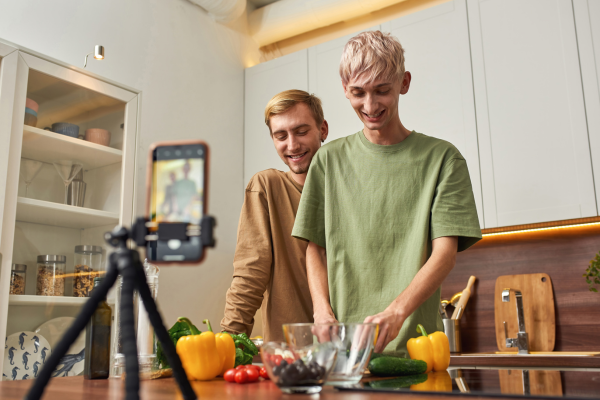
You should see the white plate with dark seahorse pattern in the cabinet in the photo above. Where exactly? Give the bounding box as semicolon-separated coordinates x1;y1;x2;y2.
2;331;52;381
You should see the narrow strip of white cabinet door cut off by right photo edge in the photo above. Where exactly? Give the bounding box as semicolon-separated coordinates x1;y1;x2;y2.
573;0;600;216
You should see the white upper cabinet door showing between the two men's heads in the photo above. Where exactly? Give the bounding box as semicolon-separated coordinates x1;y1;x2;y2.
308;25;380;143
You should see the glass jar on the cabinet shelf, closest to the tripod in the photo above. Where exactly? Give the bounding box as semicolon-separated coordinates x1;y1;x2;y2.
73;245;105;297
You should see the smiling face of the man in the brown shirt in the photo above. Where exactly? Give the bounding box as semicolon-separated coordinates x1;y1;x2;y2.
269;103;328;174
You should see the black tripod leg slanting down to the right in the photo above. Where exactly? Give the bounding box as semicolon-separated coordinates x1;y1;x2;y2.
136;263;198;400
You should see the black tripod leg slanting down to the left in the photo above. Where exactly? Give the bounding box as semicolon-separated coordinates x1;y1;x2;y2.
25;260;119;400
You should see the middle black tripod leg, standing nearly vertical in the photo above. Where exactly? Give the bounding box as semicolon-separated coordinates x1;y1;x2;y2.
119;250;140;400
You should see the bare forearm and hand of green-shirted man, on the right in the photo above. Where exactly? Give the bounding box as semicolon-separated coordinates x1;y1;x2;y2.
364;236;458;353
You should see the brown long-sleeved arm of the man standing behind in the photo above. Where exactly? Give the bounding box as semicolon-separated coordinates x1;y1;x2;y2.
221;189;273;336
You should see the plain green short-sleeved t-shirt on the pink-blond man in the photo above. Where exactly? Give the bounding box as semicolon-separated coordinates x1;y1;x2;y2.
292;131;481;356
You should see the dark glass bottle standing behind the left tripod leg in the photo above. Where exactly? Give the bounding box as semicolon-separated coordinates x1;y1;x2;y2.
83;277;112;379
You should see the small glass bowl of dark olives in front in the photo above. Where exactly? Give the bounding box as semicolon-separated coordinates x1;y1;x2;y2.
260;342;337;394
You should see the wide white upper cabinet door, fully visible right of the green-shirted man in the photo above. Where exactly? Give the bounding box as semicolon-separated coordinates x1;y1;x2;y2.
468;0;597;228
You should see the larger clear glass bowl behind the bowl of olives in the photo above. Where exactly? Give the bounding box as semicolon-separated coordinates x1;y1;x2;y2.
283;323;379;385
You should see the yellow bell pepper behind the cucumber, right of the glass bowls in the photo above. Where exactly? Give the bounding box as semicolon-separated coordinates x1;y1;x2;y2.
406;324;450;372
